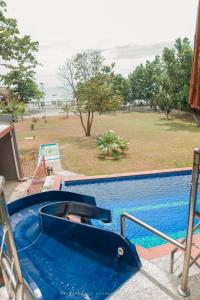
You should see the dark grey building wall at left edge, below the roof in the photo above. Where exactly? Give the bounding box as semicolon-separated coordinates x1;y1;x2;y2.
0;134;17;180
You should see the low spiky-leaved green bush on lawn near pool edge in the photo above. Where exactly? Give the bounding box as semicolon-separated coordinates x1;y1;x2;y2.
96;130;128;159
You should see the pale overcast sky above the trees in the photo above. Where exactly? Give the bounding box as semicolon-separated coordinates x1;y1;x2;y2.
6;0;198;99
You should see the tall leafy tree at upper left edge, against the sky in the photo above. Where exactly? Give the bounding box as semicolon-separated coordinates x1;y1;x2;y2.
0;1;43;102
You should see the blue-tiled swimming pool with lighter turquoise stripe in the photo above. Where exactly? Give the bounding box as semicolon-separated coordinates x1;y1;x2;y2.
61;171;200;248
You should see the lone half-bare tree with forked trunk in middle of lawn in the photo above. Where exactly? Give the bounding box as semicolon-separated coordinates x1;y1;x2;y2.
59;51;122;136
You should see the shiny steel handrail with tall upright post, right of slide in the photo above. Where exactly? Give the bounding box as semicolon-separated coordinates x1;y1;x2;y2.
121;148;200;297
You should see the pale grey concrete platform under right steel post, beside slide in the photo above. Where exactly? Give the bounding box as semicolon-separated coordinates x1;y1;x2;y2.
109;260;200;300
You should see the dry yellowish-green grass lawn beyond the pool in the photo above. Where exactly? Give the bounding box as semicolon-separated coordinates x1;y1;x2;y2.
16;112;200;175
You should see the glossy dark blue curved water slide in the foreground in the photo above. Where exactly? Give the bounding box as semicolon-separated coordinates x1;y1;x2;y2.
2;191;141;300
